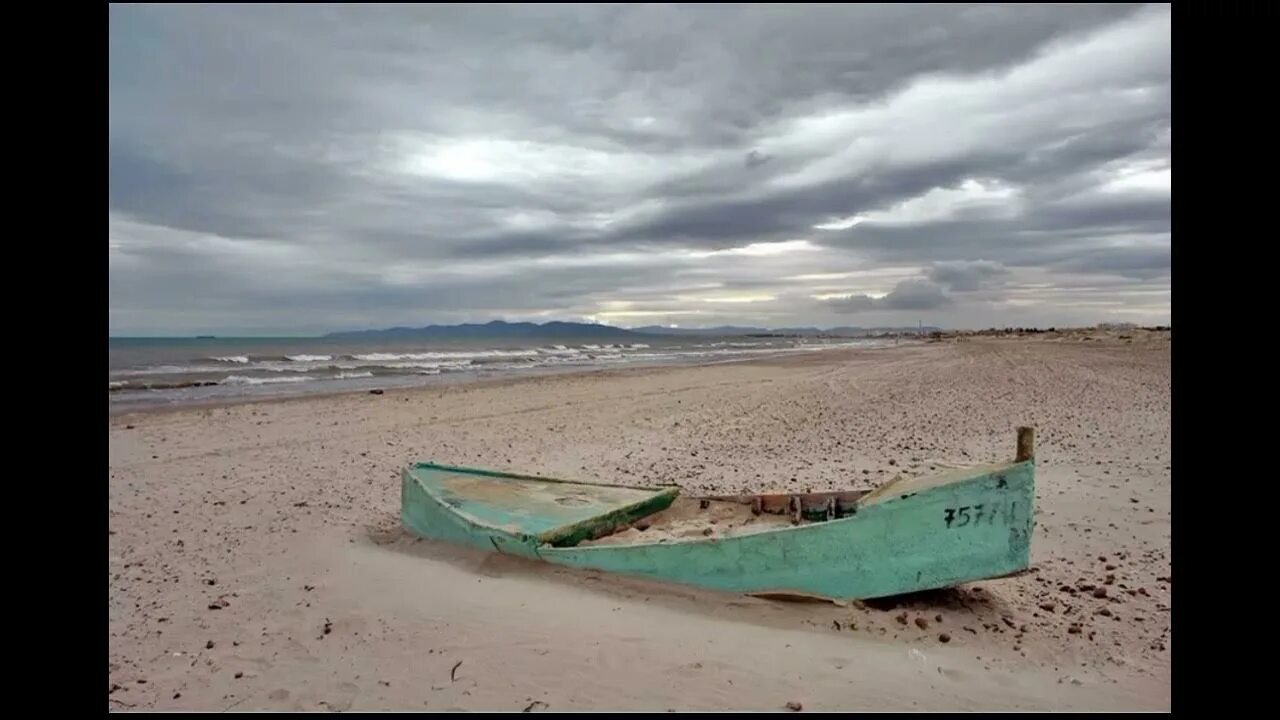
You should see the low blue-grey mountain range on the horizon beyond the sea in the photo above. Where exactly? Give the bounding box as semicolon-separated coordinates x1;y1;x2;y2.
325;320;938;340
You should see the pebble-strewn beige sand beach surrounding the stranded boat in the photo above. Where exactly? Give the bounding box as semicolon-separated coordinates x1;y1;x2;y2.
109;332;1172;711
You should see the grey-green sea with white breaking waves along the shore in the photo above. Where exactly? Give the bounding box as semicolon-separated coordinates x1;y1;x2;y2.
108;336;893;414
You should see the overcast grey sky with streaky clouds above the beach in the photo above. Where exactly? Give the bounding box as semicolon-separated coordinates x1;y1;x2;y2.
108;4;1172;334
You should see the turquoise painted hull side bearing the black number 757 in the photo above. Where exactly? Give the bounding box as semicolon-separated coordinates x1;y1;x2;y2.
538;462;1033;600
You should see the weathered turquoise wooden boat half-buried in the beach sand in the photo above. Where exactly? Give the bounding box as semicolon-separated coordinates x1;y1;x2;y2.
401;428;1036;600
